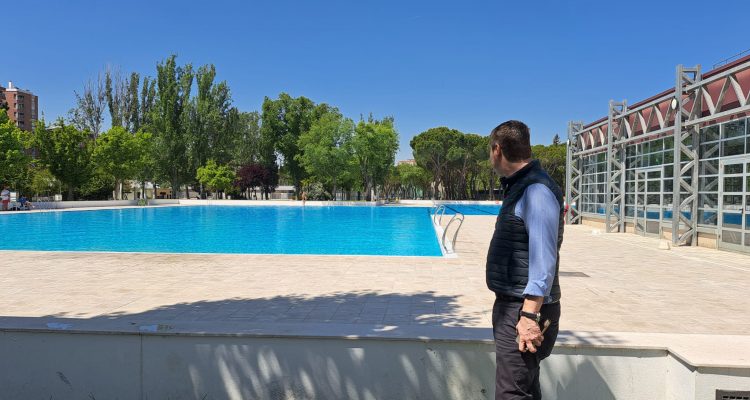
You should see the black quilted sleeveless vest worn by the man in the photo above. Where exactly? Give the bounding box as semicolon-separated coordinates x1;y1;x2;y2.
487;160;565;302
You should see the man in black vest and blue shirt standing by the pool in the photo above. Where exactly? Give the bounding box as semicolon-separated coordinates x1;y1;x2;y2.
487;121;564;400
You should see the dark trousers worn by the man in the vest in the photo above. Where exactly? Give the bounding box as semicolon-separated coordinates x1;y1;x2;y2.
492;296;560;400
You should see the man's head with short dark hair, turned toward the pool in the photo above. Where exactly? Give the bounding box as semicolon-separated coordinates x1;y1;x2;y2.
490;120;531;176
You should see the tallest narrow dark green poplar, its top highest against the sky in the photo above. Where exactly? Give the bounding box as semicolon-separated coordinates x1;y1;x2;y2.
150;55;193;197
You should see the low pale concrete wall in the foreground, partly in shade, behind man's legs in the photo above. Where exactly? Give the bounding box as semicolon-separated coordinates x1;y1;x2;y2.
0;331;750;400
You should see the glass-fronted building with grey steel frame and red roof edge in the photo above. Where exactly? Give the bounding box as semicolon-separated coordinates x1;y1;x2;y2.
566;56;750;252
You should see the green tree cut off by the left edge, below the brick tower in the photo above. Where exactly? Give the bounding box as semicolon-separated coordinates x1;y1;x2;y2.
0;109;31;189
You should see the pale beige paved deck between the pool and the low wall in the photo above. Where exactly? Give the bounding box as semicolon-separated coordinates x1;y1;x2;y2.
0;216;750;366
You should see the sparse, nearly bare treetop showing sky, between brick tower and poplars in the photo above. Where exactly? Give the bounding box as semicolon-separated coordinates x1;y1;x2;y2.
68;74;107;138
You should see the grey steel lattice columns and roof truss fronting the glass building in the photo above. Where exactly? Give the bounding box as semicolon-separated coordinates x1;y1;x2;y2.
565;57;750;245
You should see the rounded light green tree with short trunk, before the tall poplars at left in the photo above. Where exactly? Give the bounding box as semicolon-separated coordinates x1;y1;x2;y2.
92;126;141;200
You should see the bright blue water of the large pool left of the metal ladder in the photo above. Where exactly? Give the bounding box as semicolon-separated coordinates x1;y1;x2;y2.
0;206;442;256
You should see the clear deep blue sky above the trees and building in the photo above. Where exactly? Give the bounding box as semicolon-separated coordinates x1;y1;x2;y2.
0;0;750;159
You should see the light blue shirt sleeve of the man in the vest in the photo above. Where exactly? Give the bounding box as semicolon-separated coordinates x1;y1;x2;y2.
513;183;560;303
